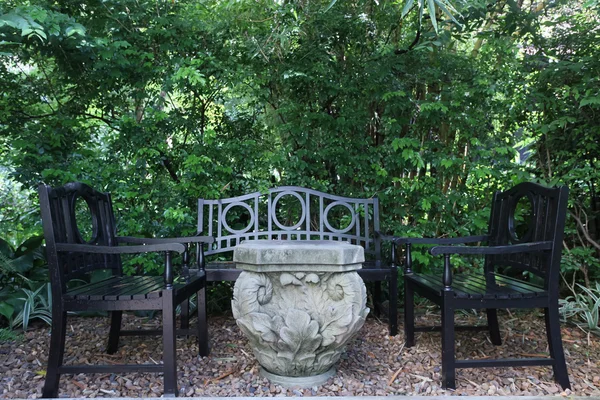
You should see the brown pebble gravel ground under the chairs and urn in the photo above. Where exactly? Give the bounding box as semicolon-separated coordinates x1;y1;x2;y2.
0;311;600;398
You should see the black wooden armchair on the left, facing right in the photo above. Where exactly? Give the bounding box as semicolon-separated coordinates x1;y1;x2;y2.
39;183;213;397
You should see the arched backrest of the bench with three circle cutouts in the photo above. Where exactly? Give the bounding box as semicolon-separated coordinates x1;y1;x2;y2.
198;186;381;261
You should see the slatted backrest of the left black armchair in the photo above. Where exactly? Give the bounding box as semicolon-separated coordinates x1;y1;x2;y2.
39;182;122;291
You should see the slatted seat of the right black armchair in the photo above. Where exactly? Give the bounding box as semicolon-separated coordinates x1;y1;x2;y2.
405;273;548;300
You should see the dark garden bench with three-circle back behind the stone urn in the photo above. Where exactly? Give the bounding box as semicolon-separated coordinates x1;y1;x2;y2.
191;186;398;352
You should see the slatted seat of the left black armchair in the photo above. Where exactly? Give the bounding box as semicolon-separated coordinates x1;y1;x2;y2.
64;276;200;301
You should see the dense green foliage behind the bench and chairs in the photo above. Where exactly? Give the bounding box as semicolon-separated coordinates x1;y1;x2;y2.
0;0;600;314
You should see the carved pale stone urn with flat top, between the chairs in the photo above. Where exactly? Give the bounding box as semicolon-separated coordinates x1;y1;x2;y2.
232;240;369;387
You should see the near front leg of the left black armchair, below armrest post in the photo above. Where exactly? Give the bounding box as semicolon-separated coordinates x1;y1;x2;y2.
162;290;179;397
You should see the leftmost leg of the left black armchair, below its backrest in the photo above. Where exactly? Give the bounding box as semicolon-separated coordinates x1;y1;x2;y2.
42;311;67;398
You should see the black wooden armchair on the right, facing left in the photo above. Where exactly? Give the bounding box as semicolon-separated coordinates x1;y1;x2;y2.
395;183;570;389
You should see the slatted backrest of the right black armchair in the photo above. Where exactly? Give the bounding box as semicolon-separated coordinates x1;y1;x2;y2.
485;182;569;288
